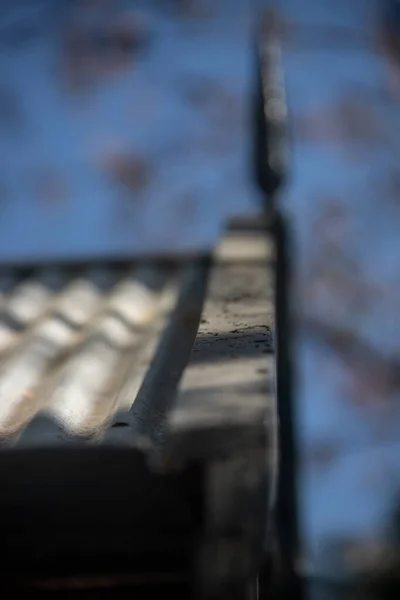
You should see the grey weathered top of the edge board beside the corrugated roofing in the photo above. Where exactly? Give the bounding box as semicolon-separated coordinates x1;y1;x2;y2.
168;233;275;455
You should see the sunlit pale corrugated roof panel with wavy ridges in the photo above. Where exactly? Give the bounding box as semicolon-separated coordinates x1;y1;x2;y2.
0;267;177;442
